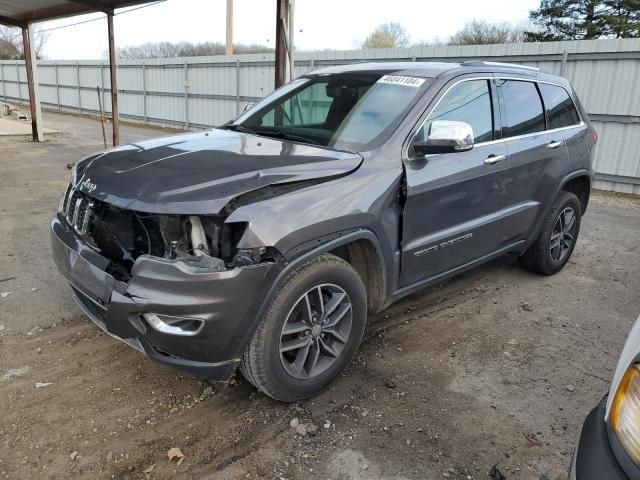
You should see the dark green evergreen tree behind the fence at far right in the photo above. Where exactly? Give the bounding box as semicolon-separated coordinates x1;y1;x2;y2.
525;0;640;41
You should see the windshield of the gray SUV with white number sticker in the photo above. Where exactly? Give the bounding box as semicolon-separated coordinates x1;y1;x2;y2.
226;72;428;150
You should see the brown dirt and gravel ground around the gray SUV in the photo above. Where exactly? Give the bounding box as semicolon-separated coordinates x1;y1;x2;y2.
0;114;640;480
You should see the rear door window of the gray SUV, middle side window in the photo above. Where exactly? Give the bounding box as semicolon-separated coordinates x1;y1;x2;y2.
498;80;544;138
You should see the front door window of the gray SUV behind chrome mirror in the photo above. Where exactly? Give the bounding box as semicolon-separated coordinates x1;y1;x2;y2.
418;80;493;143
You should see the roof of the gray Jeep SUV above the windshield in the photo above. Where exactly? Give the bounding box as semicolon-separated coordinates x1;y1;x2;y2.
309;61;552;78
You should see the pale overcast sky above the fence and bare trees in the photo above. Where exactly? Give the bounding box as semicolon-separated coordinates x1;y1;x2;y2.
39;0;540;60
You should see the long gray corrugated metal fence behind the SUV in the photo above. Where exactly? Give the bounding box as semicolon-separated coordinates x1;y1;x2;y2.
0;39;640;194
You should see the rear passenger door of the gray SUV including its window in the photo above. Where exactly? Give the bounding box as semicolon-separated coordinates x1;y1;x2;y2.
496;78;569;241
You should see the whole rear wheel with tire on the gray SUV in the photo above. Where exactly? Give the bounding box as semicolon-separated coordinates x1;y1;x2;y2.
520;191;582;275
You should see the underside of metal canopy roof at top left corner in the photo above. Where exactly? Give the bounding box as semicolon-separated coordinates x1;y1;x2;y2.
0;0;151;27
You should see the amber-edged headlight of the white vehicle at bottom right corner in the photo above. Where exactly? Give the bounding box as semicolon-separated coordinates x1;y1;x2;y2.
610;365;640;465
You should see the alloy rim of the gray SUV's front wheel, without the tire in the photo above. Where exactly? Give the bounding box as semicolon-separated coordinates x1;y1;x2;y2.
279;283;353;379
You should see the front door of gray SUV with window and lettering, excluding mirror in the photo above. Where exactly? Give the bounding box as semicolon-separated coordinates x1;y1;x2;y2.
400;79;508;287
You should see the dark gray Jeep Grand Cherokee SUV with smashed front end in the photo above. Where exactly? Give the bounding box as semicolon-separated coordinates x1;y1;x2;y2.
51;61;597;401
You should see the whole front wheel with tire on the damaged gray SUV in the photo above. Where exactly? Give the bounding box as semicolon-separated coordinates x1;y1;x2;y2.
240;254;367;402
